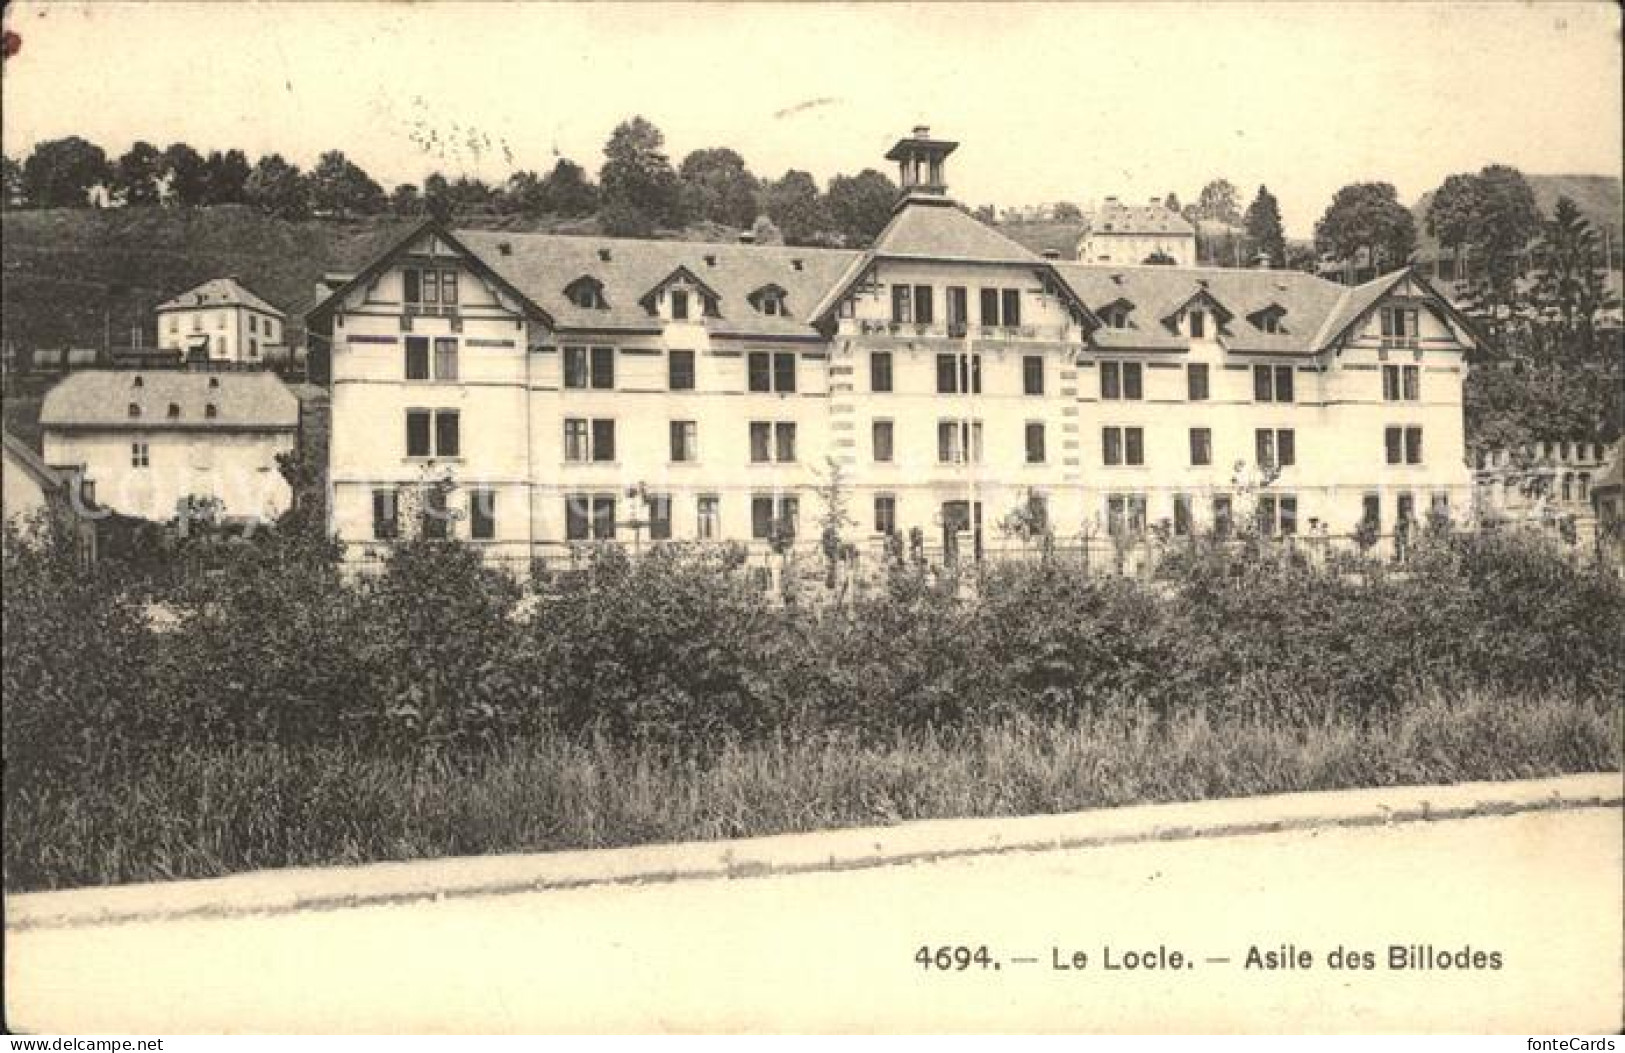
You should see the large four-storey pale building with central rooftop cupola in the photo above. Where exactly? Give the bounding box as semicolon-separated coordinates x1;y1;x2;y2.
307;130;1472;559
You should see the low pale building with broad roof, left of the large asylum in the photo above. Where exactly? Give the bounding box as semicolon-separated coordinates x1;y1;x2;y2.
39;369;299;522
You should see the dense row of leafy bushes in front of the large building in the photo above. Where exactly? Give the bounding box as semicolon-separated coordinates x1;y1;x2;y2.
3;523;1625;783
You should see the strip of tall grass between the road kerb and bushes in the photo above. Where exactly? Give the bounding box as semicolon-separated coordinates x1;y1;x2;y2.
5;692;1622;891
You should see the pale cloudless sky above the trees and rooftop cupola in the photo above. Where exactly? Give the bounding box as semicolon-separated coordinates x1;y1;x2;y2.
0;0;1625;237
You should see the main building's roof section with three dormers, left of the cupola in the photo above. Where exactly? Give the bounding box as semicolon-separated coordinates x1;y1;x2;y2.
455;231;863;338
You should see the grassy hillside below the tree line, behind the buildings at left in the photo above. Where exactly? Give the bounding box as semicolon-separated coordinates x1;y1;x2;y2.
0;205;738;348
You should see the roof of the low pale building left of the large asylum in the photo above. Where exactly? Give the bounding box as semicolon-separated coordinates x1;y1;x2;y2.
39;369;299;431
